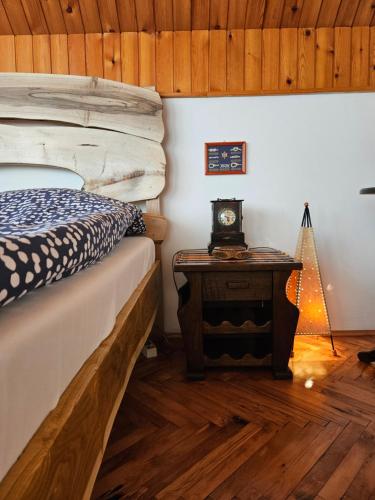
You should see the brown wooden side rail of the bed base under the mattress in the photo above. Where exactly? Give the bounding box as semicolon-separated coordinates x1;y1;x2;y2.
0;261;161;500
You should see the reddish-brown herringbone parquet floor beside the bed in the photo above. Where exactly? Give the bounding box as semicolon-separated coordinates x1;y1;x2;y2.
93;337;375;500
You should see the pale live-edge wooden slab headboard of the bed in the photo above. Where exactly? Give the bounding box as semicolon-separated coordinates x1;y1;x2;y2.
0;73;165;202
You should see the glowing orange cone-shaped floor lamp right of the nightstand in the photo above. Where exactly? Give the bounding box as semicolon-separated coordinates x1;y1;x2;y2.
287;203;337;355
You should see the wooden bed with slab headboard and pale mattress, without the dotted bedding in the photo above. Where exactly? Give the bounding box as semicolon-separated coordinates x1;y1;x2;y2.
0;75;166;499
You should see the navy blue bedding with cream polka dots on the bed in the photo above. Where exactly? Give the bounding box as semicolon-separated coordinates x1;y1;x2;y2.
0;189;146;307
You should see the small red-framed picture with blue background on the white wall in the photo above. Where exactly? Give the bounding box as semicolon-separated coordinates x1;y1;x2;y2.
205;141;246;175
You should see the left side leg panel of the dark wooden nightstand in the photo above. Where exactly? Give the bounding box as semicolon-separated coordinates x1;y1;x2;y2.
177;273;205;380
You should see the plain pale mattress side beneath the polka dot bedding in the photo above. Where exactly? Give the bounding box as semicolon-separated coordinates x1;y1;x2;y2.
0;236;155;480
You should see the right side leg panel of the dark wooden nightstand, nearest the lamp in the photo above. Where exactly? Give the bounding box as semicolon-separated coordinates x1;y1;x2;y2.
272;271;299;380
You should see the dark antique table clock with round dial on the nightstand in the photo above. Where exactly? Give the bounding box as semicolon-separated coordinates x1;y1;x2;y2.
208;198;247;255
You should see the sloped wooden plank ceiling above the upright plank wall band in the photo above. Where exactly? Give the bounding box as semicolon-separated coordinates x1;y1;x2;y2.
0;0;375;35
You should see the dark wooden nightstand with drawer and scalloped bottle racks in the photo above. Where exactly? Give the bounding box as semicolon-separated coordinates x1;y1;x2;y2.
174;248;302;380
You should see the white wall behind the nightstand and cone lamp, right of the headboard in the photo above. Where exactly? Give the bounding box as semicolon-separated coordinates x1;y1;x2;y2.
162;93;375;332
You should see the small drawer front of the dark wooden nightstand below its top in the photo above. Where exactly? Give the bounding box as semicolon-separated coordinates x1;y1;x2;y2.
202;271;272;301
